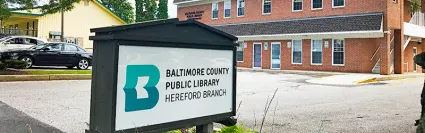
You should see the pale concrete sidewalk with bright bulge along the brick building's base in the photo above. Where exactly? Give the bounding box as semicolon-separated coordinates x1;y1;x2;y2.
238;68;425;85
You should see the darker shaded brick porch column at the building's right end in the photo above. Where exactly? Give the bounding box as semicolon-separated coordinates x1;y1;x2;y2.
394;29;405;74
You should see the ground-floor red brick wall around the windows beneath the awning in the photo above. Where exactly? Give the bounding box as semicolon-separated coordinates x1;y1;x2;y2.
238;39;379;73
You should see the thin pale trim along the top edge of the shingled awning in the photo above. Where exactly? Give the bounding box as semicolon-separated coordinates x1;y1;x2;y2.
211;12;384;27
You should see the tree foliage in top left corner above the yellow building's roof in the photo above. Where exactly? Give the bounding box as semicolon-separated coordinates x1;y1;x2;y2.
0;0;81;20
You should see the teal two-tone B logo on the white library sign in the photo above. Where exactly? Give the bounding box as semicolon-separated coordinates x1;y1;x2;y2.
124;65;159;112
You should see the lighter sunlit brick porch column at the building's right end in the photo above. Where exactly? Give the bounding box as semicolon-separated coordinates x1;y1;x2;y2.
380;34;391;75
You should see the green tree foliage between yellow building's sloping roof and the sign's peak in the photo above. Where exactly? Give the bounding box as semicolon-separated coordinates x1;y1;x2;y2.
101;0;133;23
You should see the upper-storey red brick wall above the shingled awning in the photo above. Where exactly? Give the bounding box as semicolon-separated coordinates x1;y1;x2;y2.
177;0;386;24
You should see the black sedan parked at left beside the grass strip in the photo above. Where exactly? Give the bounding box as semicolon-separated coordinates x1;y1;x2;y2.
0;43;93;69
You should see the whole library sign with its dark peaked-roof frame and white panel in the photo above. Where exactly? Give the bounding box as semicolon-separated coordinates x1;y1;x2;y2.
87;19;238;133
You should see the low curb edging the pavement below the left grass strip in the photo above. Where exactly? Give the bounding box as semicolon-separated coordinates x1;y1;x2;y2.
0;74;91;82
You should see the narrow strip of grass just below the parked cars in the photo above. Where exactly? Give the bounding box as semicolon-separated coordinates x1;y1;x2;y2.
0;70;92;75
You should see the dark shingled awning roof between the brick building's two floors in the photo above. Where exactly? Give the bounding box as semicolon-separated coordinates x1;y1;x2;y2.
212;13;383;36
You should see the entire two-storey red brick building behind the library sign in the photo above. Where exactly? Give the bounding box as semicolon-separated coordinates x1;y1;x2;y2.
174;0;425;75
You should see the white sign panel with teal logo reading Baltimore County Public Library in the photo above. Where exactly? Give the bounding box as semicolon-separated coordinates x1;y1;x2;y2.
115;46;233;130
